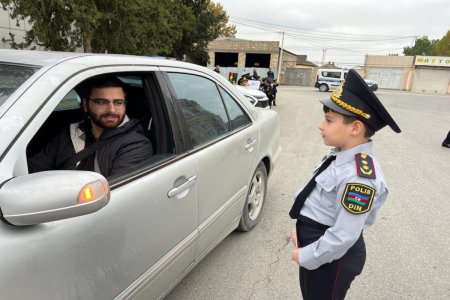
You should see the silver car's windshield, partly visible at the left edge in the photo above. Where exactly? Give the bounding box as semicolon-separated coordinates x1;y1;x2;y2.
0;63;37;106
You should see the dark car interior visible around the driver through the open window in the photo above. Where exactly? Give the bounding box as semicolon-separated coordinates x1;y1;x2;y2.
27;73;174;180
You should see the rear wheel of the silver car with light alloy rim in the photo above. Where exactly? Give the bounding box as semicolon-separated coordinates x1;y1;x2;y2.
238;162;267;231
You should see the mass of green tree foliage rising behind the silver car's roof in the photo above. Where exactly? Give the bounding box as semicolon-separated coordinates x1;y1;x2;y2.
0;0;236;64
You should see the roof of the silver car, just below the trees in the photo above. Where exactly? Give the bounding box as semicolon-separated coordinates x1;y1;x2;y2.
0;49;207;73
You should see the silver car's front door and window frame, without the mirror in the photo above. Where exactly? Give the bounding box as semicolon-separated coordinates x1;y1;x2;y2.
0;63;198;299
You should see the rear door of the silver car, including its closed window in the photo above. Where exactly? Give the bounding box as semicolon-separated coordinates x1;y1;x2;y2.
163;70;259;256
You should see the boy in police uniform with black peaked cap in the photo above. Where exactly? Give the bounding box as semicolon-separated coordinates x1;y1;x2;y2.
289;70;400;300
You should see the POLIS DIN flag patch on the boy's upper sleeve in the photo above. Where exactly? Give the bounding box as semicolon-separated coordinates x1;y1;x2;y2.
341;183;375;214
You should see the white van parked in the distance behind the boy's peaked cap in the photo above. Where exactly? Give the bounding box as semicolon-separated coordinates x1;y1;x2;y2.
314;69;378;92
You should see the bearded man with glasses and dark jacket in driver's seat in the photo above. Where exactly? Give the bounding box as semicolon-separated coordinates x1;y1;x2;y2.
28;77;153;177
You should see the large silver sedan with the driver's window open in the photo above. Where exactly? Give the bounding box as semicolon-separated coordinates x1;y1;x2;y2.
0;50;280;300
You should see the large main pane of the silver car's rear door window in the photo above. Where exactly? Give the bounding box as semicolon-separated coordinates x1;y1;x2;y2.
168;73;231;147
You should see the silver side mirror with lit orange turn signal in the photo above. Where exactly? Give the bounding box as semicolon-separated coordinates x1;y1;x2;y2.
0;171;110;225
